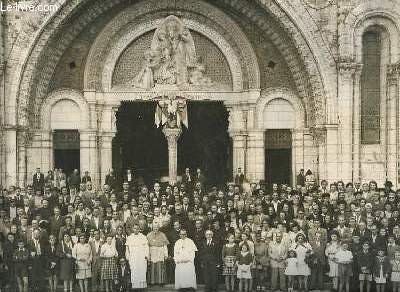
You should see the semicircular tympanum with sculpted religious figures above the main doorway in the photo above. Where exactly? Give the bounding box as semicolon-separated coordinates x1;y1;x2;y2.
113;15;232;90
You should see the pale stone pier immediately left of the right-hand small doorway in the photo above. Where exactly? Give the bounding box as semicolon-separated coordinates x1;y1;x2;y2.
246;130;265;181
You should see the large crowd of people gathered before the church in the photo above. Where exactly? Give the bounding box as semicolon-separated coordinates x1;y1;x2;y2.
0;168;400;292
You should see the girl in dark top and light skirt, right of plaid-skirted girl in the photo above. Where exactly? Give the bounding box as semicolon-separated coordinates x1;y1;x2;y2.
237;243;254;292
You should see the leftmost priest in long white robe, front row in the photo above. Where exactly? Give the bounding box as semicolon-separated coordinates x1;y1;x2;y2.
125;225;149;289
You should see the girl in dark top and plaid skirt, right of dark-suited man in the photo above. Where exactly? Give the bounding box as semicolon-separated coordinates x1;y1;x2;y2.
222;234;239;292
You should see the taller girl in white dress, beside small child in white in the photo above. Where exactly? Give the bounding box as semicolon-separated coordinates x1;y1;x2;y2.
289;233;313;291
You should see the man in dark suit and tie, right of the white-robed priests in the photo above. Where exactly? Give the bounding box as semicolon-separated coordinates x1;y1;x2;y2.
200;230;220;292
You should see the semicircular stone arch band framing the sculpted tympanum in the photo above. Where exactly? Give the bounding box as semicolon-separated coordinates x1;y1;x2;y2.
84;0;260;91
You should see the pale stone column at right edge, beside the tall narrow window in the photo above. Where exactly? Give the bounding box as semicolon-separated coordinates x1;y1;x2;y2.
386;64;400;189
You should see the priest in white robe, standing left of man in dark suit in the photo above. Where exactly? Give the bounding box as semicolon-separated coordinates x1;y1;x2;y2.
174;229;197;289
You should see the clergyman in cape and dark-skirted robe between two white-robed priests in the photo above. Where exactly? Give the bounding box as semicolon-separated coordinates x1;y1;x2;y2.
147;223;169;286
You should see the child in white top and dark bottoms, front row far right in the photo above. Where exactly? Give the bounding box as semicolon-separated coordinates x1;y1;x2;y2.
335;241;353;292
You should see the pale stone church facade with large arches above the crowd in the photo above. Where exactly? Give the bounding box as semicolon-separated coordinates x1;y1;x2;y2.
0;0;400;186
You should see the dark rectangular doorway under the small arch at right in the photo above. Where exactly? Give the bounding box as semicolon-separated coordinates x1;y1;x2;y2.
265;129;292;185
